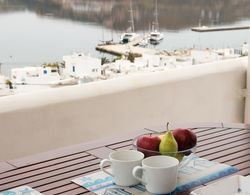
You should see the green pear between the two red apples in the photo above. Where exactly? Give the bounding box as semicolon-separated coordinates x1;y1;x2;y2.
159;130;178;157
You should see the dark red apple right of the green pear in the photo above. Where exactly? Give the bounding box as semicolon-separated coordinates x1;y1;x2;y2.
173;128;197;151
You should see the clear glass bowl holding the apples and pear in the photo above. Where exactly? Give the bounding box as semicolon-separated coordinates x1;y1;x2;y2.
132;133;196;163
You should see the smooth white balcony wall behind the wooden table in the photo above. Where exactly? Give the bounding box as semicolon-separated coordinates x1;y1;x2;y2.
0;58;247;161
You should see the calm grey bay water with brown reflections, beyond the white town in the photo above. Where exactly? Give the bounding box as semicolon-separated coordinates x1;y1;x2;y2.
0;0;250;75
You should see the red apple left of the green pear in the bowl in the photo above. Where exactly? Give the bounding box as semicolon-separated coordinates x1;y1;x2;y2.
136;134;161;157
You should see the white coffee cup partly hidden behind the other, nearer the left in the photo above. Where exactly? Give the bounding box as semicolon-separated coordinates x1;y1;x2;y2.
100;150;144;186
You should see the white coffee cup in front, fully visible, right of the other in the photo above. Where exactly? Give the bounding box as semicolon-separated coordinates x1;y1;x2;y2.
133;155;179;194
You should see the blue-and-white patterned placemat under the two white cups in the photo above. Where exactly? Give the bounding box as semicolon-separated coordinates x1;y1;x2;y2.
72;155;237;195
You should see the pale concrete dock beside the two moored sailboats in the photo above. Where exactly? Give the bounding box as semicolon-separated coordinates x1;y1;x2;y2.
96;36;159;56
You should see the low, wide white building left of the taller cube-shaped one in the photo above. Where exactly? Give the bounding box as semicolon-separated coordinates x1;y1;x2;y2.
11;67;60;85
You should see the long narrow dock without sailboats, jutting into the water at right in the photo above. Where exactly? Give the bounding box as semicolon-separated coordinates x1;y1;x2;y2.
191;26;250;32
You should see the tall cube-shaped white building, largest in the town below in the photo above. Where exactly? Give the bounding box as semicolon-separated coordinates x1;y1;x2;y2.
63;53;101;79
